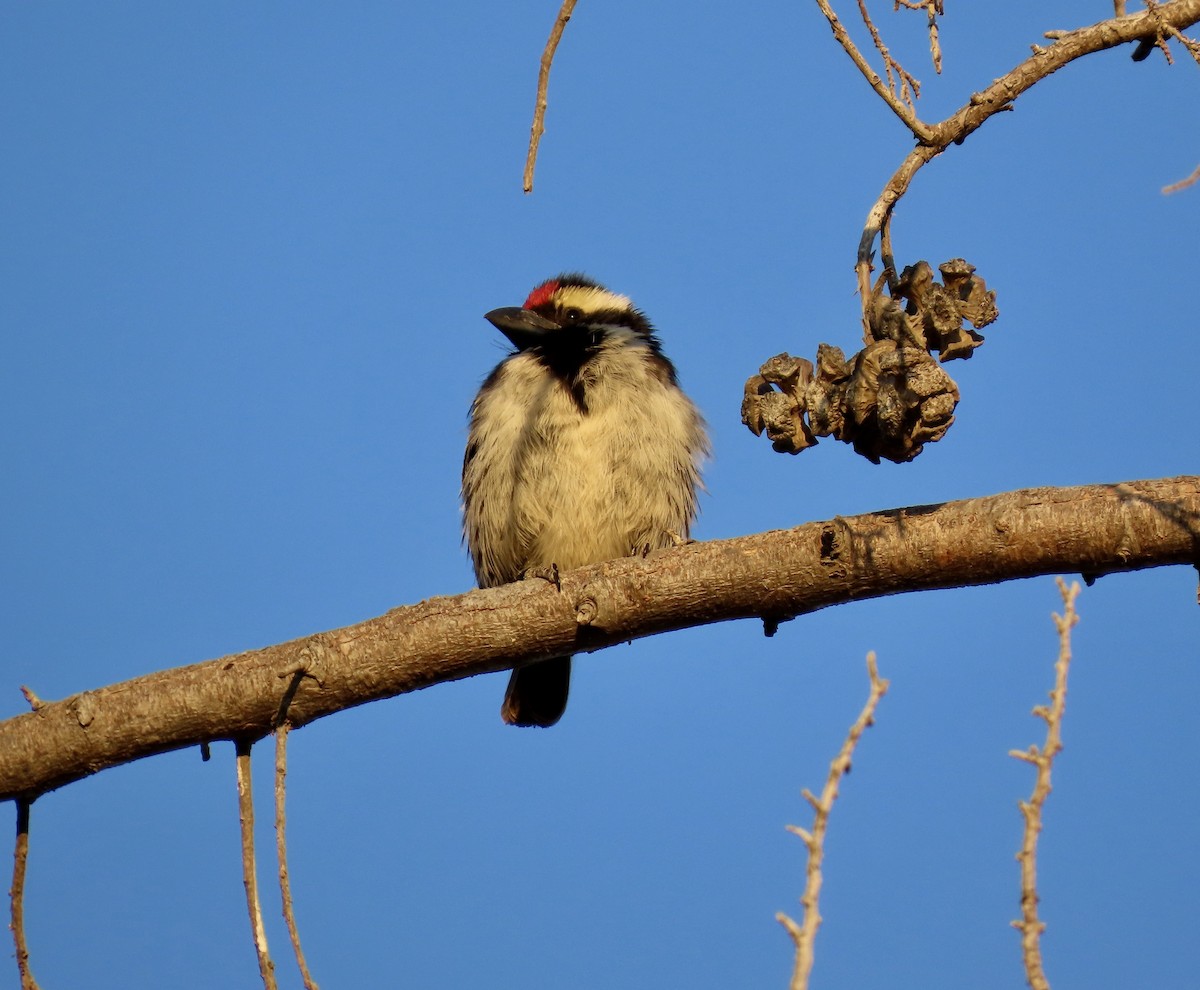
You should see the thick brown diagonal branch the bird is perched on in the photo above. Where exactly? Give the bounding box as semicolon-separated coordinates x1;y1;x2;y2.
0;476;1200;799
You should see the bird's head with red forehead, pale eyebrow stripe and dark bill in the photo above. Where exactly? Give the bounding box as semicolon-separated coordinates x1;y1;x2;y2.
484;272;659;358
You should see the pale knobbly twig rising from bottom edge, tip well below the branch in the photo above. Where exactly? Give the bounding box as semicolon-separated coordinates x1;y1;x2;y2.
775;652;888;990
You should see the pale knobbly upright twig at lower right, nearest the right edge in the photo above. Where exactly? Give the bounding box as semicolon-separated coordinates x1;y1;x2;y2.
1009;577;1079;990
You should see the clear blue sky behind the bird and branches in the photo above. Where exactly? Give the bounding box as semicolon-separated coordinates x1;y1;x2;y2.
0;0;1200;990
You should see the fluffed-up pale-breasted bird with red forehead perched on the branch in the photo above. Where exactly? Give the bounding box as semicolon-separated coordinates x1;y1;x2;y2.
462;272;709;726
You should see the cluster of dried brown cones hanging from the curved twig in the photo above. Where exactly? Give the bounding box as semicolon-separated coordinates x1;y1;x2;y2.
742;258;998;464
